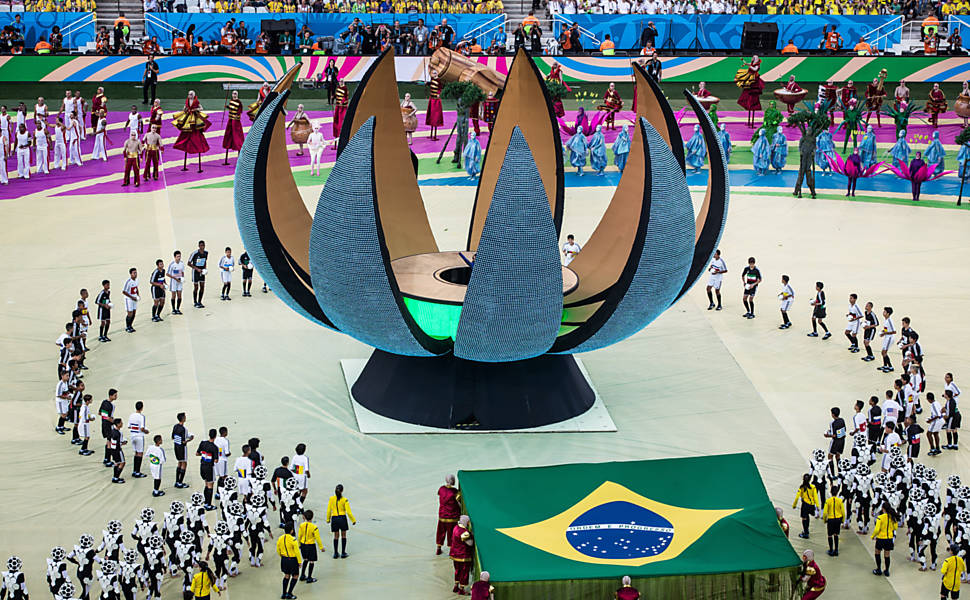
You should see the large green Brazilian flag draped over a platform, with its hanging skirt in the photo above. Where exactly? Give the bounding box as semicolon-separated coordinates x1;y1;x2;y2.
459;454;800;600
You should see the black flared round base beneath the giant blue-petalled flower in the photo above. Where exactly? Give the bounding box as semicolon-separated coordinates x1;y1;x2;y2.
351;350;596;430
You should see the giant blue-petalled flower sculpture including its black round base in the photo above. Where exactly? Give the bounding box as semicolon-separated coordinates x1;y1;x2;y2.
235;50;728;429
